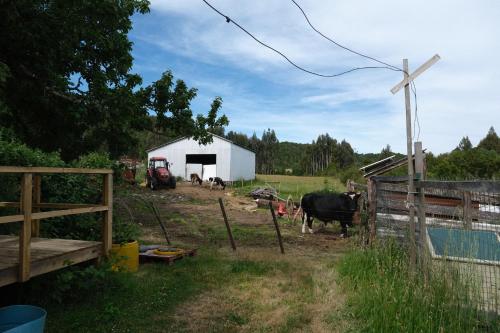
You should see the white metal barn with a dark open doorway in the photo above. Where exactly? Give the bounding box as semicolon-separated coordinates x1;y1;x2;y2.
147;134;255;181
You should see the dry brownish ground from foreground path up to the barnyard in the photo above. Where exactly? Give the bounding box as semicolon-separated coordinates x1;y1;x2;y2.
115;182;350;332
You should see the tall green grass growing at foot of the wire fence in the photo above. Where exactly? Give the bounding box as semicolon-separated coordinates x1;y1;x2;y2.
338;242;499;332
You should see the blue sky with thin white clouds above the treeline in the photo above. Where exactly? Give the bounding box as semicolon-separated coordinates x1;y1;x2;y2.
129;0;500;153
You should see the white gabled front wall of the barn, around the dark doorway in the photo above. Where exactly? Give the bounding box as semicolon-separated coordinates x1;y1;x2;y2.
148;136;231;180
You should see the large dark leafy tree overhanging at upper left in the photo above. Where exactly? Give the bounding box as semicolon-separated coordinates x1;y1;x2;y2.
0;0;227;160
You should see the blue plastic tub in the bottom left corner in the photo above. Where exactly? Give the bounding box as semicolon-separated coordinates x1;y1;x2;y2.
0;305;47;333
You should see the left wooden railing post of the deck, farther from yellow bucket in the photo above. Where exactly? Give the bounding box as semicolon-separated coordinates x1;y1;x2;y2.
19;173;33;282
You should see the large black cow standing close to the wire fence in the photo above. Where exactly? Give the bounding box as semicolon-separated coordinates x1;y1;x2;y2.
300;192;361;237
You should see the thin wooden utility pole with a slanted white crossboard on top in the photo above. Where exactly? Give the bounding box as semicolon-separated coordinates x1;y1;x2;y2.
391;54;440;269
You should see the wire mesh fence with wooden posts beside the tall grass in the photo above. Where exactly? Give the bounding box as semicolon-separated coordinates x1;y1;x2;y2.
370;177;500;318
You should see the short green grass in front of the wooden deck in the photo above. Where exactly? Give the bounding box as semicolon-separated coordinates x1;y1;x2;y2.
4;248;310;332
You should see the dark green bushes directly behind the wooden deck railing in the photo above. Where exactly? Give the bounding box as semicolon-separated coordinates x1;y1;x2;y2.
0;140;137;240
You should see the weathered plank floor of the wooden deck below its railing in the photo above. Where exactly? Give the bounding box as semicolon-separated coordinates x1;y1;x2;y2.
0;235;103;287
